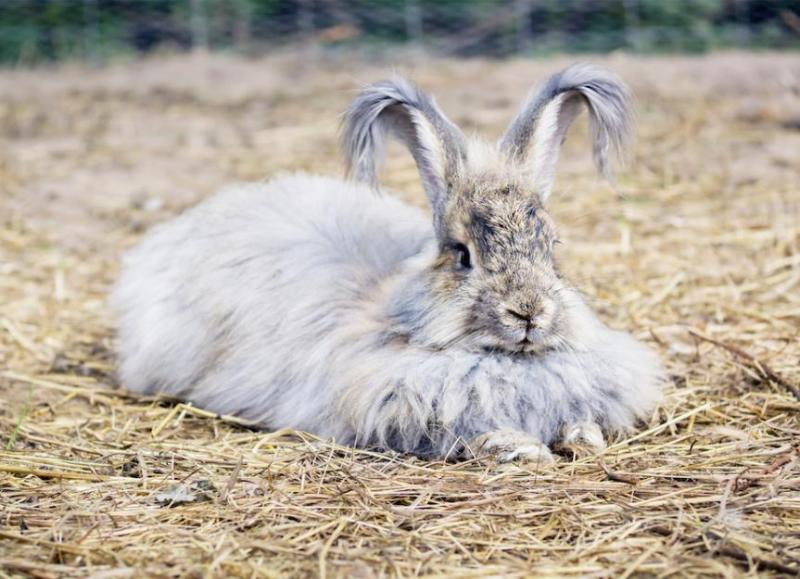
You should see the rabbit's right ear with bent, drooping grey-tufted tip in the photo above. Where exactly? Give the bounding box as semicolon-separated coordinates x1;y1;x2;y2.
500;64;632;201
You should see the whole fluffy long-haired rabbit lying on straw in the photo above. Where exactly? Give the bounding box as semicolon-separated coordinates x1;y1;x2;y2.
112;64;663;462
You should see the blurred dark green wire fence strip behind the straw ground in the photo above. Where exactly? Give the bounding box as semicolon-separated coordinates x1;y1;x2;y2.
0;0;800;65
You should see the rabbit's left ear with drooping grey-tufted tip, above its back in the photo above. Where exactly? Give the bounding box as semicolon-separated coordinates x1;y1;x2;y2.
342;76;465;232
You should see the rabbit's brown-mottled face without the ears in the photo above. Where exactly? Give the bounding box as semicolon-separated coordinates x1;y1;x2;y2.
436;186;567;353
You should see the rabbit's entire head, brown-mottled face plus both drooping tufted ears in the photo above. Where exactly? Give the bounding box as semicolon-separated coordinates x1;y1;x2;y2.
343;65;631;352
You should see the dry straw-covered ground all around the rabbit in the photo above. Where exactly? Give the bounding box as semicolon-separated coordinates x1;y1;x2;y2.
0;54;800;577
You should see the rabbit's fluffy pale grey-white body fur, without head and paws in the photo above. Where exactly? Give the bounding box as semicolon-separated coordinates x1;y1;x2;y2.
113;175;659;456
